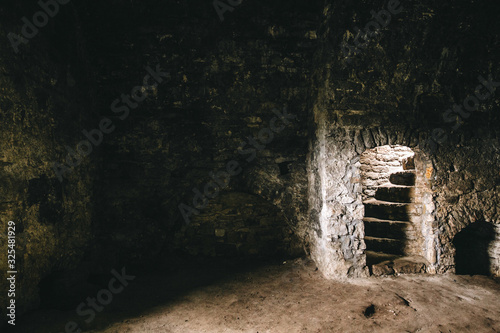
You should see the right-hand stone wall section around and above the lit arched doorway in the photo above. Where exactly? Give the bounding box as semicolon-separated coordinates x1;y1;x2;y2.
309;1;500;277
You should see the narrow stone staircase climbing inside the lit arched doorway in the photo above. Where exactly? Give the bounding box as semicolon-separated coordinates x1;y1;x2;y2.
363;160;425;275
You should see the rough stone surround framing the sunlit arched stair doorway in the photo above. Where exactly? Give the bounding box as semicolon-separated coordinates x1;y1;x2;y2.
308;125;440;279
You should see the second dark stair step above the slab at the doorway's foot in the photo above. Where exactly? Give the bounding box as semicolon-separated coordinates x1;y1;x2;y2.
363;217;416;239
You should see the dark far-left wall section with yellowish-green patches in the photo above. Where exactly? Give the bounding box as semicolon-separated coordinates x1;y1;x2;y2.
0;2;97;325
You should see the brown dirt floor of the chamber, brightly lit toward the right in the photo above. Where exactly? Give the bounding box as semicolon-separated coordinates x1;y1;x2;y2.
5;259;500;333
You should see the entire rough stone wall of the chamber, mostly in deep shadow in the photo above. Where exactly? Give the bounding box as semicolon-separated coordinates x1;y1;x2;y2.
0;0;500;322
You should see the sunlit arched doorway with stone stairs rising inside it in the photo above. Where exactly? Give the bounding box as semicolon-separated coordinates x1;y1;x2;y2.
360;145;435;275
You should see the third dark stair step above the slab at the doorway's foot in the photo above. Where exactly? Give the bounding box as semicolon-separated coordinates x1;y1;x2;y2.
363;199;416;222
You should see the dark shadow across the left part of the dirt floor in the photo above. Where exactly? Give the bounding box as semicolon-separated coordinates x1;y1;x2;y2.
2;258;292;333
